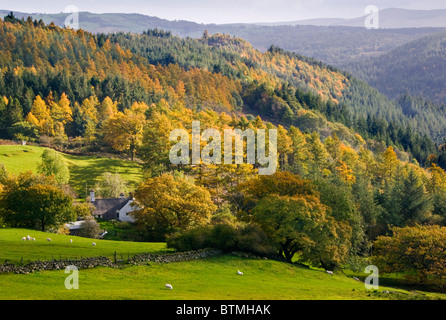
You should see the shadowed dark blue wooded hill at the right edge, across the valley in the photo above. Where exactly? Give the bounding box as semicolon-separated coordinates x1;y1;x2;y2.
344;32;446;105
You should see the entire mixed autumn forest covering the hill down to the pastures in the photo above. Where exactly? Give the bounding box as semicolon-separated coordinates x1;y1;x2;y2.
0;15;446;289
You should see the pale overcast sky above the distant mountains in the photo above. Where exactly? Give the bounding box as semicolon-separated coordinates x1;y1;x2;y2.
0;0;446;23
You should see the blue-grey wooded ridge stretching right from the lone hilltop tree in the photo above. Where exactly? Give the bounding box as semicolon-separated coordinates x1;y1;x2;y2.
208;25;446;67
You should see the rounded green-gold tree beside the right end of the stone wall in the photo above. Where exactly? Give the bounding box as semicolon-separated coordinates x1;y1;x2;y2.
253;191;351;269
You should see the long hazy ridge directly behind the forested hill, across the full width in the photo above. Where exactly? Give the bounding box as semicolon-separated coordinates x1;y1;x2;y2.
0;9;446;67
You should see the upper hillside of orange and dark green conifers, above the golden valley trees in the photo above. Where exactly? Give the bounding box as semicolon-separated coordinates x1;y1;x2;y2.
0;14;439;164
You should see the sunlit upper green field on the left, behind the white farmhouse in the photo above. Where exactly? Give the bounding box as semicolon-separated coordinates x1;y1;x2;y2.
0;145;142;198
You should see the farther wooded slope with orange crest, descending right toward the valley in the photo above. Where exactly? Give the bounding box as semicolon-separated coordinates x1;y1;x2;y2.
104;32;445;163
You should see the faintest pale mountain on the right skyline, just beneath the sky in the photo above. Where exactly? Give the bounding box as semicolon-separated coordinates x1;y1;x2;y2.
260;8;446;29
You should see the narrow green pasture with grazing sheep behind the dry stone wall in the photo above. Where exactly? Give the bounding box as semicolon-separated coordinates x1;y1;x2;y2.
0;228;171;264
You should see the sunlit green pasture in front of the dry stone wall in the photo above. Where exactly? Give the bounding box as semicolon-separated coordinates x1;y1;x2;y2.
0;256;412;300
